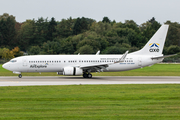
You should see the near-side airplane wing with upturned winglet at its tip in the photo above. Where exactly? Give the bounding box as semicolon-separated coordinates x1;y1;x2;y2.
79;51;129;72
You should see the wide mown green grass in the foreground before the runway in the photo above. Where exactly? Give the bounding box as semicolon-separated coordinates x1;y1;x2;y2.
0;84;180;120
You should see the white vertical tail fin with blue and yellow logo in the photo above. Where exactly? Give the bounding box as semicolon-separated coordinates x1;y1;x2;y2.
131;25;169;56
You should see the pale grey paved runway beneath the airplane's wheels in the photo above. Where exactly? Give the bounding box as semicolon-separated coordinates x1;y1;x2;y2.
0;76;180;86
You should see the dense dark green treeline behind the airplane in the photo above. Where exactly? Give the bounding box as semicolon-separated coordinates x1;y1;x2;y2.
0;13;180;57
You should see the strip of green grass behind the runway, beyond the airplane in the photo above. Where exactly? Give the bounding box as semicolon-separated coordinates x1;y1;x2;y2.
0;64;180;76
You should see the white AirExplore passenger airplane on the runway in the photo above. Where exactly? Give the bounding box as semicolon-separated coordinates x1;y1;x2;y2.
2;25;172;78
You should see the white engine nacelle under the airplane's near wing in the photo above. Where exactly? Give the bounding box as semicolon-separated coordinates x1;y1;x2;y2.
63;67;83;75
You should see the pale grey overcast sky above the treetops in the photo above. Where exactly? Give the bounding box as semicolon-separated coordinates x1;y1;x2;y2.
0;0;180;25
